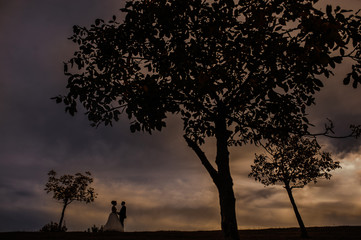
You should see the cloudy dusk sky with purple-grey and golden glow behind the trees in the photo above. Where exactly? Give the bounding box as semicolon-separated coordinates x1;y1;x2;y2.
0;0;361;231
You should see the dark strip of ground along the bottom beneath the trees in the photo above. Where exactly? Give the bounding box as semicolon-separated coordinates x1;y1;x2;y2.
0;226;361;240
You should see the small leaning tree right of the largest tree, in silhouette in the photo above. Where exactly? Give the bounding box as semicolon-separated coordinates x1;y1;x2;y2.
249;136;340;238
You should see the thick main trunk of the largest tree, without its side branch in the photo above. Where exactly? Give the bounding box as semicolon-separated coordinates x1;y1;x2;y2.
213;113;239;240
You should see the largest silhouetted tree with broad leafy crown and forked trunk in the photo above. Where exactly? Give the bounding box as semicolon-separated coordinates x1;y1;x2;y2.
55;0;361;239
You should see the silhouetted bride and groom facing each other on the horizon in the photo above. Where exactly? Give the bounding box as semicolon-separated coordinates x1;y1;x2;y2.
104;201;127;232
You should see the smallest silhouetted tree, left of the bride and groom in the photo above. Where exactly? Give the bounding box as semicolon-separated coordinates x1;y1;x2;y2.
44;170;97;230
